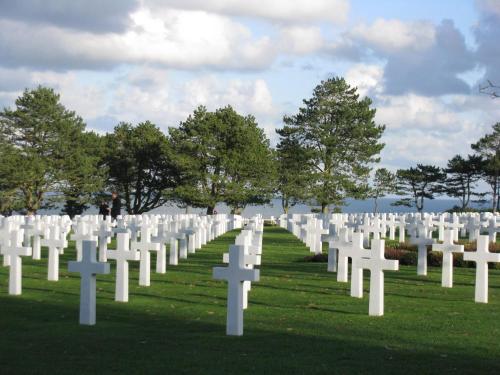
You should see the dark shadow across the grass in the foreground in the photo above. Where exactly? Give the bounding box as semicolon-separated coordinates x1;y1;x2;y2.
0;296;500;375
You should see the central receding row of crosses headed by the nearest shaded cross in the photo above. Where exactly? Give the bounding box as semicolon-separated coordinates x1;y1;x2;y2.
213;216;264;336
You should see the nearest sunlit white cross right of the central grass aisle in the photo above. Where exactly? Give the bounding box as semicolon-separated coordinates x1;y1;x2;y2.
359;240;399;316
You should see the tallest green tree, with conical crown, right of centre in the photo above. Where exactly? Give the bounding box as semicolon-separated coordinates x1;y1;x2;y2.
277;78;385;213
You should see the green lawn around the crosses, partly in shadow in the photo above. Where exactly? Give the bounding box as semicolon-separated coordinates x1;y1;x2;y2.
0;227;500;375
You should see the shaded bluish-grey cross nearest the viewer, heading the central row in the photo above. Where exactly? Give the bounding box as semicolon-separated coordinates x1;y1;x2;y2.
213;245;260;336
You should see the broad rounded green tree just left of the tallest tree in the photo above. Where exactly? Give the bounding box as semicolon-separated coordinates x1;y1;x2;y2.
170;106;275;214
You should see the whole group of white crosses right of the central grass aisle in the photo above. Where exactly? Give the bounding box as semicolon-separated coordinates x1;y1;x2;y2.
280;214;500;315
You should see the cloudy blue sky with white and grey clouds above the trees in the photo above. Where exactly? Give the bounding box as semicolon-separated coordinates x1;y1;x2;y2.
0;0;500;169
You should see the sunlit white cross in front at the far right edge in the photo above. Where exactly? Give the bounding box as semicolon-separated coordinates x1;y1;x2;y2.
464;235;500;303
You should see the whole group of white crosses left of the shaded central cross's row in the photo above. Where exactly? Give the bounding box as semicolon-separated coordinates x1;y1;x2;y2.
0;215;241;324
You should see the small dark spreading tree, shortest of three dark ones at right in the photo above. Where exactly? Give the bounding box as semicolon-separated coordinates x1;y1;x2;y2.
393;164;445;212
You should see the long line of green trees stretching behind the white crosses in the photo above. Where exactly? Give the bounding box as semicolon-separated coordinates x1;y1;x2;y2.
0;82;500;216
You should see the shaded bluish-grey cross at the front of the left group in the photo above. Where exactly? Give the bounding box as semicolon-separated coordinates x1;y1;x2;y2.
68;240;109;325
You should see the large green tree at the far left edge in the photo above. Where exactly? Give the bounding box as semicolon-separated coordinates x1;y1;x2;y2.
0;86;85;214
